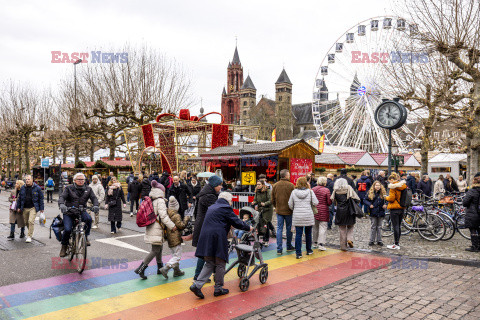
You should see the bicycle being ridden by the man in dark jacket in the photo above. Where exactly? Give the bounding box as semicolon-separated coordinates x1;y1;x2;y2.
67;206;87;274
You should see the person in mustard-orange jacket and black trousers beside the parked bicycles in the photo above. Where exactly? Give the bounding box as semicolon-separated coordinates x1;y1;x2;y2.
385;172;407;250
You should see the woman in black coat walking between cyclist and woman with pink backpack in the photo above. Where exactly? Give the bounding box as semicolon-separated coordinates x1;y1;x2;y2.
105;177;127;234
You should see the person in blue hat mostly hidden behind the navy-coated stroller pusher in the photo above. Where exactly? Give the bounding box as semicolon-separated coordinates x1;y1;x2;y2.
192;175;222;280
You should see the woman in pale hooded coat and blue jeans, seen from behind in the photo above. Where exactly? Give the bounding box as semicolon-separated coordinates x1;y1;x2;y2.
288;177;318;259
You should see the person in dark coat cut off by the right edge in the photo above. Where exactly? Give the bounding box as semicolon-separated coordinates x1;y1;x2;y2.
463;172;480;252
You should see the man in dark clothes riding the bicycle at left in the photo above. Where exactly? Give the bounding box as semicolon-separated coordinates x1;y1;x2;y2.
58;173;99;257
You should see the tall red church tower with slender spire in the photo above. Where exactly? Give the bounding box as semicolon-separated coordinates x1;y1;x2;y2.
222;47;243;124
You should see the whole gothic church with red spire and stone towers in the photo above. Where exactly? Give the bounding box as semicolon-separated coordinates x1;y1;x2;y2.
221;47;318;141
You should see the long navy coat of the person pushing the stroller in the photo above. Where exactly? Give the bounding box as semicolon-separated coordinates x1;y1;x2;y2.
195;199;250;262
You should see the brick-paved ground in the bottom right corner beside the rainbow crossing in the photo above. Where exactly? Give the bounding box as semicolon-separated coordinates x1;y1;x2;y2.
239;262;480;320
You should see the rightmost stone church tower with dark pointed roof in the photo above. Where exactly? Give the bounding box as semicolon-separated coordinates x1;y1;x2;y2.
275;69;293;141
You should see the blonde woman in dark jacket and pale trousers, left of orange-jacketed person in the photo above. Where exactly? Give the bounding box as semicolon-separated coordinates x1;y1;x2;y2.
364;181;387;246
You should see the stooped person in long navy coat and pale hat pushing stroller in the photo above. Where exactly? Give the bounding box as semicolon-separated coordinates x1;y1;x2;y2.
190;192;253;299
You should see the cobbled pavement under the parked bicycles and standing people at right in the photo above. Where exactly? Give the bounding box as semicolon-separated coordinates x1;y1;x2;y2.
327;218;480;261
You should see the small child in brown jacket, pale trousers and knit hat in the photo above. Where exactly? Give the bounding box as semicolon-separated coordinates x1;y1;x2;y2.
160;196;190;279
